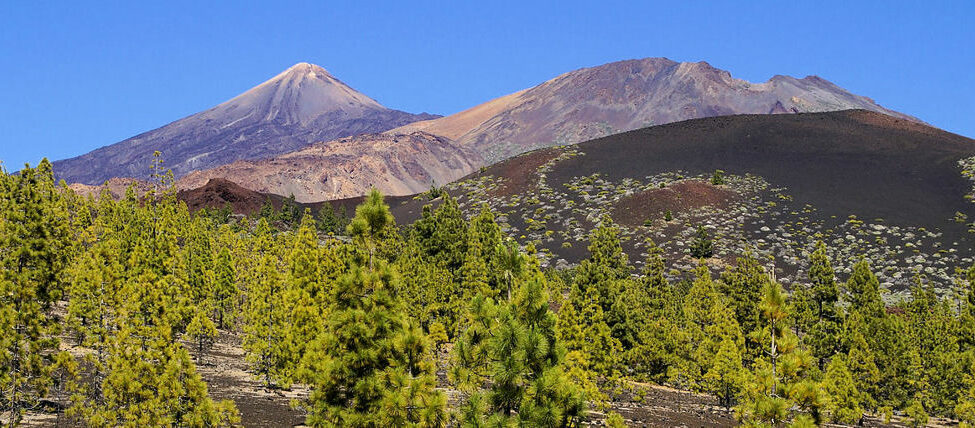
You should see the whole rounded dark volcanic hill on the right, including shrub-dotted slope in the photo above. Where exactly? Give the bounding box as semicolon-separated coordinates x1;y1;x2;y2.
394;110;975;290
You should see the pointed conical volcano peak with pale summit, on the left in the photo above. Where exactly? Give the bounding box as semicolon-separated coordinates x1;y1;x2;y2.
54;63;437;184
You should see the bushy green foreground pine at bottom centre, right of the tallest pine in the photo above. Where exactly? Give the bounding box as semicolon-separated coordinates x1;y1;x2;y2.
450;274;585;427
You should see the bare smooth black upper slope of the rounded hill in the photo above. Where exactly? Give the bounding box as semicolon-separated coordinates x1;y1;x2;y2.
556;110;975;232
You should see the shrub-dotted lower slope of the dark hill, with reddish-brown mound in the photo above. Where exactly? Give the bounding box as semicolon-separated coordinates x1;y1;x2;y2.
424;144;973;301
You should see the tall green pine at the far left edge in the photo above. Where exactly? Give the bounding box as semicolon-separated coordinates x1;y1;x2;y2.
0;159;67;425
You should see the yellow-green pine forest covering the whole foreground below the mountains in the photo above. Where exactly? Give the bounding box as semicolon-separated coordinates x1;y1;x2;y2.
0;161;975;427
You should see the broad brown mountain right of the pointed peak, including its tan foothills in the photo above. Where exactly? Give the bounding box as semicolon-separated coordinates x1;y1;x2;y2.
187;58;917;201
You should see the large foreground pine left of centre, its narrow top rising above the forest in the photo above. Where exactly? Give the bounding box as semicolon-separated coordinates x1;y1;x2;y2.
302;189;446;426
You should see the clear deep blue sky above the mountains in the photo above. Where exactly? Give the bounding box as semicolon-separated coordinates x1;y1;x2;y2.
0;0;975;169
